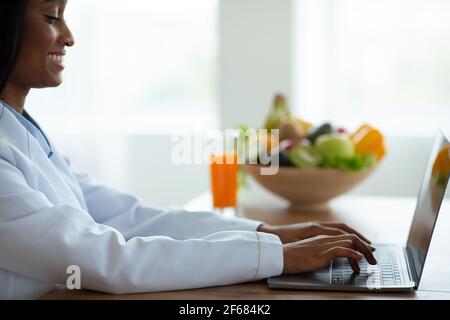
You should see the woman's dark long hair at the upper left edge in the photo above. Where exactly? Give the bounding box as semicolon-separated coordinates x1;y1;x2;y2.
0;0;28;96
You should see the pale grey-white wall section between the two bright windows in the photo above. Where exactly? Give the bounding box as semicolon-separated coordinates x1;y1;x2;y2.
218;0;293;128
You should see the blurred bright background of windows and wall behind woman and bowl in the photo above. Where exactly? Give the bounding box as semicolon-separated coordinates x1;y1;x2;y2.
27;0;450;206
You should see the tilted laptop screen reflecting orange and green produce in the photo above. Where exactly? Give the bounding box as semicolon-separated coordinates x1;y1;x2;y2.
408;131;450;280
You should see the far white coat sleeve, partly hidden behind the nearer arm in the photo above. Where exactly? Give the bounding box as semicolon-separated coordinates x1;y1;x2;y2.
64;157;268;240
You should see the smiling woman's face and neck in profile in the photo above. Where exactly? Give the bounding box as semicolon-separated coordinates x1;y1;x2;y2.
0;0;74;113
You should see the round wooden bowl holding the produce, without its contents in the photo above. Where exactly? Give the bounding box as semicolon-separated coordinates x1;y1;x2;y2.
243;165;377;211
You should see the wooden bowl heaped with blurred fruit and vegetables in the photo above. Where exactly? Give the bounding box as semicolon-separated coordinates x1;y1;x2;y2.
241;95;386;211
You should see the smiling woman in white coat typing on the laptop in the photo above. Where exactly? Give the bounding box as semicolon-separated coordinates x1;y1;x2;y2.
0;0;376;299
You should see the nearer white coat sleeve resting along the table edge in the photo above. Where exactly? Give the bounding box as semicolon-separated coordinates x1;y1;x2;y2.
0;156;283;294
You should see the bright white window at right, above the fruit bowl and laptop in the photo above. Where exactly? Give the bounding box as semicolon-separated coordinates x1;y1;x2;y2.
295;0;450;135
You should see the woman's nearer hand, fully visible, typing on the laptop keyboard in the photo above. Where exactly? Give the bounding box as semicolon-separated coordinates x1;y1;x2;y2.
283;234;377;274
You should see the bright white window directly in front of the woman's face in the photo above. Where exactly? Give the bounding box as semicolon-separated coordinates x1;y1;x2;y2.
28;0;218;133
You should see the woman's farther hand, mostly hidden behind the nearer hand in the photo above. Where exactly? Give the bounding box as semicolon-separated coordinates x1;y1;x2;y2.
258;222;371;244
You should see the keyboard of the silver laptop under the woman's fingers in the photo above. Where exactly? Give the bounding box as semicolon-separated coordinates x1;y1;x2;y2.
331;246;404;287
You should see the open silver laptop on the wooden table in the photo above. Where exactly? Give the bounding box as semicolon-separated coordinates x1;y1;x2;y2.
267;130;450;291
